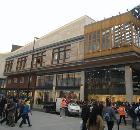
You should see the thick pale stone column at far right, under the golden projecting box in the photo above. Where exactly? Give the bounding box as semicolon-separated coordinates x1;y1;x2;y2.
125;66;133;104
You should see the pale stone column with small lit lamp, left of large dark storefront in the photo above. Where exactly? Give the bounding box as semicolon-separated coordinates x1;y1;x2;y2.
80;71;85;101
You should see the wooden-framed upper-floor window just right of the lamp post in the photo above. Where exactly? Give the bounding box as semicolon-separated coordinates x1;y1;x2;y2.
32;51;46;68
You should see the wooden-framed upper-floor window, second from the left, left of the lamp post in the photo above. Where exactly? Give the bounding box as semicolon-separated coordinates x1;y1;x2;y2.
17;56;28;70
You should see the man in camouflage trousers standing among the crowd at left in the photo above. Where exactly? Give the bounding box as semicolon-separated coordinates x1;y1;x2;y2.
7;97;16;127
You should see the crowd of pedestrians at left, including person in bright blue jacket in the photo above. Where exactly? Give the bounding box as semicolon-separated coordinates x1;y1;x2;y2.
0;96;33;127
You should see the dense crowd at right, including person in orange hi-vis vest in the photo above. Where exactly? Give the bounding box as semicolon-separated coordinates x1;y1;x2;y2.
79;101;140;130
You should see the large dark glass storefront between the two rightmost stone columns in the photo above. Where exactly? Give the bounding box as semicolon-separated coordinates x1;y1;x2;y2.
85;67;126;101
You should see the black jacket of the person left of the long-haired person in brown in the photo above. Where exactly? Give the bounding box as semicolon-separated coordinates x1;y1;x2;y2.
81;105;90;120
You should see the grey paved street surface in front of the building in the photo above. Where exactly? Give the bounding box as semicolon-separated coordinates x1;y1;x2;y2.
0;108;140;130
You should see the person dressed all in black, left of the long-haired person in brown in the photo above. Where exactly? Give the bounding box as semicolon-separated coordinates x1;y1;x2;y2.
81;102;90;130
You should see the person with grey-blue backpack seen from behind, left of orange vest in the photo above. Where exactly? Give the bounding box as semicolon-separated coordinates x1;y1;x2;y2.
105;102;117;130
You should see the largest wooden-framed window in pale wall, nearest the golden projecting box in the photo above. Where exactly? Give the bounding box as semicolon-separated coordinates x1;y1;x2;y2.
52;45;71;64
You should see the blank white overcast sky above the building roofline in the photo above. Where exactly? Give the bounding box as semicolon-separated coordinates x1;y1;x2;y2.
0;0;140;53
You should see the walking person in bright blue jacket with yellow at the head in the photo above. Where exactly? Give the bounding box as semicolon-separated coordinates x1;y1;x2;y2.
19;101;32;128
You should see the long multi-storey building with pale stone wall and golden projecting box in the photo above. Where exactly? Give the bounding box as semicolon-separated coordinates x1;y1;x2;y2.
4;6;140;102
